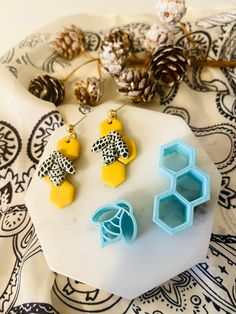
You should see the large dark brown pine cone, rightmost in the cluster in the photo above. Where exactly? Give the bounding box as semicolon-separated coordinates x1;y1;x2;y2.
151;45;188;86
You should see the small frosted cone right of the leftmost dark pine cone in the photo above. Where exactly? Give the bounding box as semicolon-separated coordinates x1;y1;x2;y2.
74;76;104;106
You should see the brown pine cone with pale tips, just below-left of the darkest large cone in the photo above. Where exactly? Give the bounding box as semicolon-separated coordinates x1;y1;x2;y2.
116;68;157;103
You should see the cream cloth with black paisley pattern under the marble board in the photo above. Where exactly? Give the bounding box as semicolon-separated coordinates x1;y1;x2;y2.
0;11;236;314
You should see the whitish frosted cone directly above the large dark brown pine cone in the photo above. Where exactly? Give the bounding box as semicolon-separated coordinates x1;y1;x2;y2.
144;24;173;55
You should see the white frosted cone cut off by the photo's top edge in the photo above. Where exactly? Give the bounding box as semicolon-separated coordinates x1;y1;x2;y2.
156;0;187;25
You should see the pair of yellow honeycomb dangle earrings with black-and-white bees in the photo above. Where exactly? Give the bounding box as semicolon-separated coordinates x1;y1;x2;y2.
38;105;137;208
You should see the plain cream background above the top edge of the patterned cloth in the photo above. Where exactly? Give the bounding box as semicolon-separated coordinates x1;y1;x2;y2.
0;0;236;55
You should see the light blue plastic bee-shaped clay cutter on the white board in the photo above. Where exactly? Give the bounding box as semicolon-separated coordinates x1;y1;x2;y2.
91;200;137;247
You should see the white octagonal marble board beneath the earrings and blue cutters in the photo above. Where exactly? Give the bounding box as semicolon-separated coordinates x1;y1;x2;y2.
24;102;221;299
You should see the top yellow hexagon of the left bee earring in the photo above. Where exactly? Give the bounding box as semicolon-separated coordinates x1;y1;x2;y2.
57;136;80;160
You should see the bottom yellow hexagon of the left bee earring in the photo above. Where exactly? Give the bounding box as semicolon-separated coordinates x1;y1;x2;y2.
50;181;75;208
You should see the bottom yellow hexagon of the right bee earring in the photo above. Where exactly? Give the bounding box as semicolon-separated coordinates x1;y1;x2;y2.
102;161;125;188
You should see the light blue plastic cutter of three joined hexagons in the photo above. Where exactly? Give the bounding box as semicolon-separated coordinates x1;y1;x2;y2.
153;140;210;234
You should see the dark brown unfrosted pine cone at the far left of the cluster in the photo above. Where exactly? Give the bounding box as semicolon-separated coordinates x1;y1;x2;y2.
28;74;65;106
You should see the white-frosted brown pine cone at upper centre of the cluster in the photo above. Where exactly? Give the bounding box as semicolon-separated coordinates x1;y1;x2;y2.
99;29;133;76
